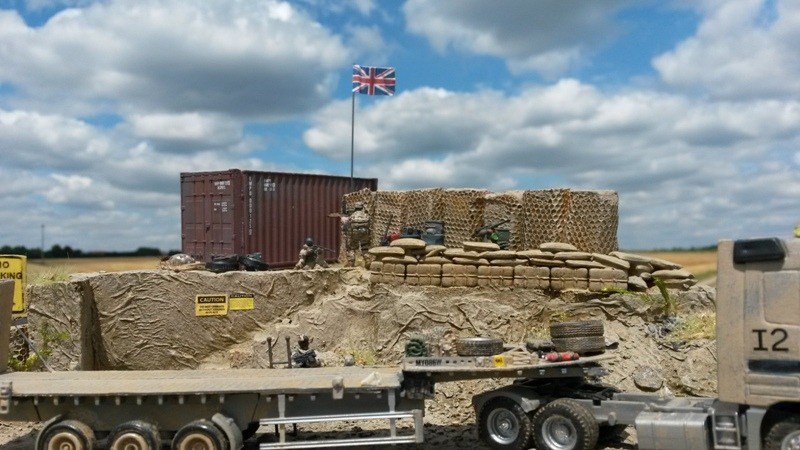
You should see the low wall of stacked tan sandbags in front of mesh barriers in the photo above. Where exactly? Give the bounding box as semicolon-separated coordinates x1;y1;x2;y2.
369;239;696;292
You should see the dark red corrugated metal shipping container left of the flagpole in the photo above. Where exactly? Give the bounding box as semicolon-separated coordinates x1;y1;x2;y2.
181;169;378;268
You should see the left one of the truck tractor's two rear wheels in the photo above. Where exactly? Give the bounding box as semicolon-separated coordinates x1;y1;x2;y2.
478;398;532;450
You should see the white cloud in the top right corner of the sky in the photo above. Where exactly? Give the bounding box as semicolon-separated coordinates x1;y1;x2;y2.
653;0;800;99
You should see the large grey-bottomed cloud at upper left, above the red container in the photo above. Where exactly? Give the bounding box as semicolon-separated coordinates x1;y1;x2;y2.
0;0;349;118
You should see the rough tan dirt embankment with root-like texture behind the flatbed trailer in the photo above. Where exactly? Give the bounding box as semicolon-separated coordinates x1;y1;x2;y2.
0;269;716;449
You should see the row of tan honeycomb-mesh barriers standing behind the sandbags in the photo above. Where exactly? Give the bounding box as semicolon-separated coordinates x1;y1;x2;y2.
344;189;619;253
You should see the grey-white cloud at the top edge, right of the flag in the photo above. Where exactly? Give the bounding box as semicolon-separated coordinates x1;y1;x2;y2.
403;0;631;77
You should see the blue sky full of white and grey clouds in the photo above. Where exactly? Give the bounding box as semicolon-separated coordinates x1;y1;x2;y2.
0;0;800;251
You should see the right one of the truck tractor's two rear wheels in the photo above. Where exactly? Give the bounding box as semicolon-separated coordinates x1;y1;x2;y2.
533;398;600;450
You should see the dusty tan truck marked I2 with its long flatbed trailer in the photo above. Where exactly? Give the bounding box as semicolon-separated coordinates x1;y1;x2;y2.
0;238;800;450
